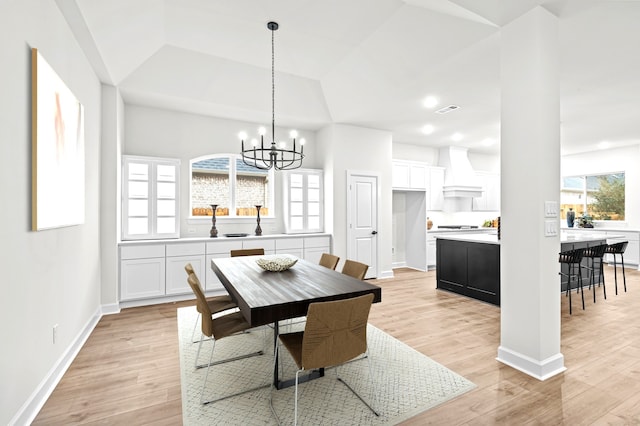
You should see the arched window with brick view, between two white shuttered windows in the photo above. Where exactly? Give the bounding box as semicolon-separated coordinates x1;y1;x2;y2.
189;154;273;217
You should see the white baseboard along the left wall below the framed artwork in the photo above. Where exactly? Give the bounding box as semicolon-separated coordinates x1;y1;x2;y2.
9;308;102;425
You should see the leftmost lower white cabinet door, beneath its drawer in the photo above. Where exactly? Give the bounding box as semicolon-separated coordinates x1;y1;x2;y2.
120;256;165;300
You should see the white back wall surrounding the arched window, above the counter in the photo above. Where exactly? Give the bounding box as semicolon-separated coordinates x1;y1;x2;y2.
122;105;321;237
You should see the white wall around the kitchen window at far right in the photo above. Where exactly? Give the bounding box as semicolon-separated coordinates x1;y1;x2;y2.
561;145;640;229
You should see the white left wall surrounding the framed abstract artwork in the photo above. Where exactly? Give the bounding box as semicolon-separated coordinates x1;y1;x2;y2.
0;0;101;424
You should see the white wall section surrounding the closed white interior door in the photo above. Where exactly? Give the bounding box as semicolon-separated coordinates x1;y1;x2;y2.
317;124;393;277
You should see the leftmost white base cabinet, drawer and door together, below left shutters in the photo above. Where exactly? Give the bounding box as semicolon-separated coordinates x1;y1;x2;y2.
120;244;165;300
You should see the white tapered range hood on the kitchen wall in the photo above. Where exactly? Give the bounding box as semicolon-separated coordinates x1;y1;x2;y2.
439;146;483;199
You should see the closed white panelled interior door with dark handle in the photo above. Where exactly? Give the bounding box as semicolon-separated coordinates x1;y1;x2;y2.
347;172;379;278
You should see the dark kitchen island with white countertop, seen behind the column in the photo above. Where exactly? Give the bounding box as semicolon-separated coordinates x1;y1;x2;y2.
436;233;606;306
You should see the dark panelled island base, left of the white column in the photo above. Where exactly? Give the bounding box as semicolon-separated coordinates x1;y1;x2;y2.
436;238;500;306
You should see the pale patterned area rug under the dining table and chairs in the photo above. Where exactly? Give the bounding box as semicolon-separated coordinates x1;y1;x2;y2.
178;307;475;425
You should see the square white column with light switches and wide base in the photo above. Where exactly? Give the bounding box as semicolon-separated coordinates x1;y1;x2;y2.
497;7;564;380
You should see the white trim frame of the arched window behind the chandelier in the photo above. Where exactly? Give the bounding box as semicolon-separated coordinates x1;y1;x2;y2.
188;153;275;223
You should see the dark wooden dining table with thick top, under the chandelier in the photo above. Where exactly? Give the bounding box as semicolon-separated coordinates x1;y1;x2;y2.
211;256;382;389
